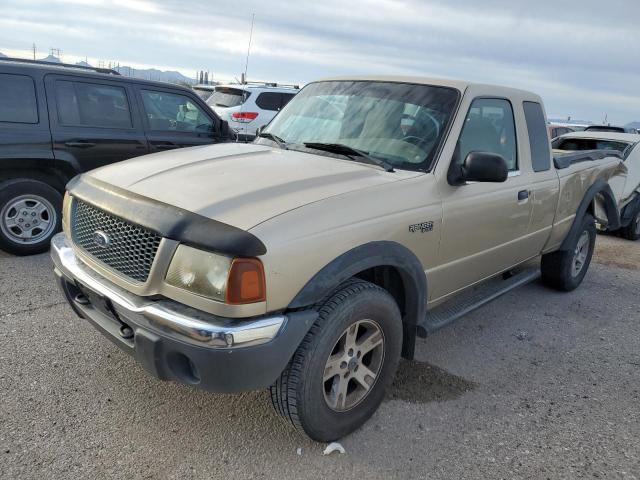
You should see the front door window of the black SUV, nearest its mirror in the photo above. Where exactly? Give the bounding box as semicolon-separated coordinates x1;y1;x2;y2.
140;90;213;133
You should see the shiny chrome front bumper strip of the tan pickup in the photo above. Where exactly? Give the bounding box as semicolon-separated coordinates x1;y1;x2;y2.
51;233;287;349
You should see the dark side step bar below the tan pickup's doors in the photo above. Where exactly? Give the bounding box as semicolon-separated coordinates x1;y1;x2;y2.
418;268;540;338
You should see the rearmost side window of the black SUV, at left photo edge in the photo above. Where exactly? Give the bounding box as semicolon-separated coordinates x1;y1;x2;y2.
0;73;38;123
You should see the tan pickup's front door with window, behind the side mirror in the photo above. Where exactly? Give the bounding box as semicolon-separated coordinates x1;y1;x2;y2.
427;97;532;301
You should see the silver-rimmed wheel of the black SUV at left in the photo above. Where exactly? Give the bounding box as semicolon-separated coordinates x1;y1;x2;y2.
0;178;62;255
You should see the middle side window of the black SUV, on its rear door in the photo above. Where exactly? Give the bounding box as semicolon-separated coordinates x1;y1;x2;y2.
55;80;132;128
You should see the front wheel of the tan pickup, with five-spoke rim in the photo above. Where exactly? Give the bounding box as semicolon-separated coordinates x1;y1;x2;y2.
270;280;402;442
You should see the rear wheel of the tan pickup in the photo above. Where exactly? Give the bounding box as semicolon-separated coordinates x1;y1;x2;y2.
541;214;596;292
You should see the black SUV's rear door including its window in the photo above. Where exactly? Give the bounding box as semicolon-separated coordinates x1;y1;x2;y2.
45;75;147;172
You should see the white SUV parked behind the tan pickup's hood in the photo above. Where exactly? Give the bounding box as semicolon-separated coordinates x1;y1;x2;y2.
207;83;299;139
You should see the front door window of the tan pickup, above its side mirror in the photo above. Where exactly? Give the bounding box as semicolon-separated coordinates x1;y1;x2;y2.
459;98;518;171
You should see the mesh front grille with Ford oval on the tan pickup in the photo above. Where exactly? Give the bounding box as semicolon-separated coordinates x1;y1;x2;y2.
71;200;162;282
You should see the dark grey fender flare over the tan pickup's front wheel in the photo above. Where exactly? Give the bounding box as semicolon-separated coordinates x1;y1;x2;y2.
289;241;427;326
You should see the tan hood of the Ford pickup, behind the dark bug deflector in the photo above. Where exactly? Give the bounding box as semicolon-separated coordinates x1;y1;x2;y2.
89;143;421;230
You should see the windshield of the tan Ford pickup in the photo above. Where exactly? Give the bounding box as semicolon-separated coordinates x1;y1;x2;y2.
258;81;459;170
